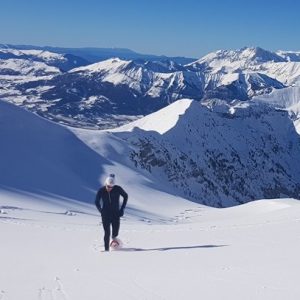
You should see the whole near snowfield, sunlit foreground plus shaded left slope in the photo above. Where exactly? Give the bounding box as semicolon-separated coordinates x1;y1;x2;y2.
0;101;300;300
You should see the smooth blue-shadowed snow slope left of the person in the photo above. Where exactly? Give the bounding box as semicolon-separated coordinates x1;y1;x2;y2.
0;101;108;201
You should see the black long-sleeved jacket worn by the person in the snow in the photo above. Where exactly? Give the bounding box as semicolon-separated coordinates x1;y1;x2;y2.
95;185;128;217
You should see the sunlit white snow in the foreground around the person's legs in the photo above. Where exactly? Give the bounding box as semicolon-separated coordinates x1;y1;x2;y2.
0;191;300;300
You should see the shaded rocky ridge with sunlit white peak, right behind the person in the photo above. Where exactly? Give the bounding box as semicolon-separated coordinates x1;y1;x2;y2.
71;99;300;207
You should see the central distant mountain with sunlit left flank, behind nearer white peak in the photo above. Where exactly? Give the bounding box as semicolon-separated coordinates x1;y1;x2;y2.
70;58;201;103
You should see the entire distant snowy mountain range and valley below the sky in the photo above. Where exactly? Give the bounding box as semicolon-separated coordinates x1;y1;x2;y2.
0;47;300;128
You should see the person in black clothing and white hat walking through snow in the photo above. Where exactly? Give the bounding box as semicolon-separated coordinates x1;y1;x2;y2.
95;174;128;251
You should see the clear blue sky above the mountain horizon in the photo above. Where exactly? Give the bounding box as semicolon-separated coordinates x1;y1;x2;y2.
0;0;300;58
